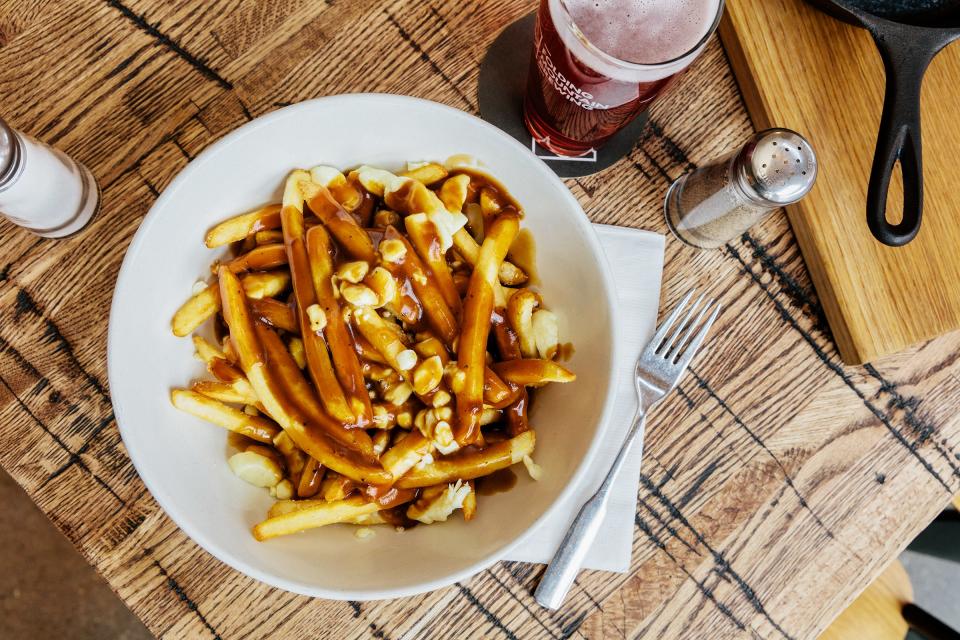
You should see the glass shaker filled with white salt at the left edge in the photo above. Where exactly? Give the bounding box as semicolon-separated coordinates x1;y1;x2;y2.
0;120;100;238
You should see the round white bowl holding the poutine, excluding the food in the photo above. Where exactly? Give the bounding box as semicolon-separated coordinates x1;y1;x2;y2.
107;94;615;600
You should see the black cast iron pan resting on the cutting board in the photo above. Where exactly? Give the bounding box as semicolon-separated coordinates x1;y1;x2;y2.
808;0;960;247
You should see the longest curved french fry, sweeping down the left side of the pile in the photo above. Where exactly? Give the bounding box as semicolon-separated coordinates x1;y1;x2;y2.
220;267;393;484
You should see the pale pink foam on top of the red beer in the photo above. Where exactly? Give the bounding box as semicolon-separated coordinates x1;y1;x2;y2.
549;0;721;82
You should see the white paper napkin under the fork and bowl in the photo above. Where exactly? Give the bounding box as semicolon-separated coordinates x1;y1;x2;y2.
506;224;664;573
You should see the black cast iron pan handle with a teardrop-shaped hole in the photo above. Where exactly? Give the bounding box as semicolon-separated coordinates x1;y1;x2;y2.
867;23;946;247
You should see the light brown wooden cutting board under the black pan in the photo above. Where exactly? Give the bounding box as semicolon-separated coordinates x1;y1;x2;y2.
720;0;960;364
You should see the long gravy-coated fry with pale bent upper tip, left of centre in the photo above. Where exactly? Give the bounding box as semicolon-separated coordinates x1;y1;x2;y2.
280;170;357;423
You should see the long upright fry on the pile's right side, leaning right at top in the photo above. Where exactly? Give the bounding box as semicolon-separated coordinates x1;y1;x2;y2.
454;213;520;445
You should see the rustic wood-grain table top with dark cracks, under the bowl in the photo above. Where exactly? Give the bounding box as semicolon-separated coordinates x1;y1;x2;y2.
0;0;960;639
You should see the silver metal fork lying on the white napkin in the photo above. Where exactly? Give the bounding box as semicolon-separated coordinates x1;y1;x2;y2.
534;291;720;609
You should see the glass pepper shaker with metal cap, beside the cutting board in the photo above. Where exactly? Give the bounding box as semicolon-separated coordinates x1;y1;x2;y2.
664;129;817;249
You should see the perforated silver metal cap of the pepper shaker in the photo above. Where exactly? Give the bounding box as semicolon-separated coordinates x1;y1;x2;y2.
738;129;817;205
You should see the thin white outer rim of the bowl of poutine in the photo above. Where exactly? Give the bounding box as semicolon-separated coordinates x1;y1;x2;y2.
107;93;620;601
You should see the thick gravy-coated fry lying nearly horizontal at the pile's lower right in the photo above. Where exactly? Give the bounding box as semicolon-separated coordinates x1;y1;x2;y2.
394;429;536;489
